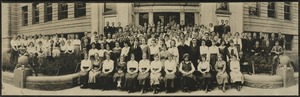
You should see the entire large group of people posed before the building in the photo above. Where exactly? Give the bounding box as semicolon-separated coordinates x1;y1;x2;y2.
11;21;285;93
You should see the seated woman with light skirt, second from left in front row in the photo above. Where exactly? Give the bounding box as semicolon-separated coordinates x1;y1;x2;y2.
88;53;102;89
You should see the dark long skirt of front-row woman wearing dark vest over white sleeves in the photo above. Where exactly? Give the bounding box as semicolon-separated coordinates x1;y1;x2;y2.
181;74;195;89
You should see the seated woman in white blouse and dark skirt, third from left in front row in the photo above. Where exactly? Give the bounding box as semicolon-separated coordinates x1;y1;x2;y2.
99;53;114;90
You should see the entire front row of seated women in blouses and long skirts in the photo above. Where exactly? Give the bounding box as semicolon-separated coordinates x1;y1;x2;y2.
79;53;243;94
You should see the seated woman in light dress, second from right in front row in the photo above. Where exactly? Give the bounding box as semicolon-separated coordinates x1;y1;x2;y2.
215;55;228;92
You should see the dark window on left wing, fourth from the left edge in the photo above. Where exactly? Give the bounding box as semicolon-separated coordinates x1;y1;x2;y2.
58;3;68;20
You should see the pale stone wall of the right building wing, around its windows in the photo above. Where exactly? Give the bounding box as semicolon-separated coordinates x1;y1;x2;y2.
243;2;298;54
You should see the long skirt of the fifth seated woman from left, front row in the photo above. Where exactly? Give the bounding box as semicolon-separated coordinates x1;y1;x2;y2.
125;73;138;90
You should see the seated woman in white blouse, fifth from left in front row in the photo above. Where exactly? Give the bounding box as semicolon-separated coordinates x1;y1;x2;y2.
125;54;139;93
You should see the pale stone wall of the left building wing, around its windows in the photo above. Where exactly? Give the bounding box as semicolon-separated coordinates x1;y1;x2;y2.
16;3;91;35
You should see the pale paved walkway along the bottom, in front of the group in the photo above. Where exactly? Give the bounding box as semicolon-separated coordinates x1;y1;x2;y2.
2;83;299;96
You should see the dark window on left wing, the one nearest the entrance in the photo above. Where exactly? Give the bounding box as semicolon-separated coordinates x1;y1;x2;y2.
75;3;86;18
